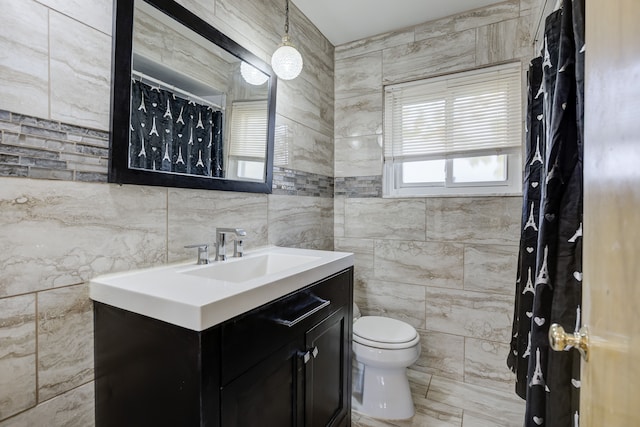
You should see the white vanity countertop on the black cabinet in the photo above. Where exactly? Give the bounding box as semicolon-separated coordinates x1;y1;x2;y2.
89;247;353;331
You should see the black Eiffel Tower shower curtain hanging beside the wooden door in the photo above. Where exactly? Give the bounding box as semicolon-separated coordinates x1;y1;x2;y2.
507;0;585;427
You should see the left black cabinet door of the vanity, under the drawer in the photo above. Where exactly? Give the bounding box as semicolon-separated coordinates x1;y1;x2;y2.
221;341;303;427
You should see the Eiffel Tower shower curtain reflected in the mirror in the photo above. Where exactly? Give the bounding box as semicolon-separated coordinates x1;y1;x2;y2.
129;80;223;177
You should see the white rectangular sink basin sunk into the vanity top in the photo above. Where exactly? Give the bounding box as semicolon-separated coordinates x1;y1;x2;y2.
180;253;320;283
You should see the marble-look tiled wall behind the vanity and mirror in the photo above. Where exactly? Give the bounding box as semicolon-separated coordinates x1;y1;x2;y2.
0;0;334;427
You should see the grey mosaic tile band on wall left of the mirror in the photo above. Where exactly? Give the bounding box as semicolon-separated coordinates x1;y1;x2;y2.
0;110;109;182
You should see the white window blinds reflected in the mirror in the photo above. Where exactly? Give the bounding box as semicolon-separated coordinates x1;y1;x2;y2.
229;101;268;159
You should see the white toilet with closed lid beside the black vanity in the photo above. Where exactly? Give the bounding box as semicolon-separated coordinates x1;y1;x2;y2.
351;304;420;420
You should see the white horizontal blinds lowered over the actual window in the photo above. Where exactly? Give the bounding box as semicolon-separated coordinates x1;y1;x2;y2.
384;63;522;161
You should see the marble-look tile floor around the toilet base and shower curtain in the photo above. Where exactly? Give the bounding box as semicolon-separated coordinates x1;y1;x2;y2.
352;369;524;427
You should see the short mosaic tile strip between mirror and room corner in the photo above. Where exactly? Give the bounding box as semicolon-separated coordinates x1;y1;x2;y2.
273;166;334;198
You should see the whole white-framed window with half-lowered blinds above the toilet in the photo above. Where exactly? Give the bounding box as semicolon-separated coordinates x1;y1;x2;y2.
384;63;522;197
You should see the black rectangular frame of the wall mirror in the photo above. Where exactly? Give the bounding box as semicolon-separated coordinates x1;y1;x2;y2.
108;0;277;193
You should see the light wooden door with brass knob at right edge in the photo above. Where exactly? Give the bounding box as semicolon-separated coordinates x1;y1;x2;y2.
580;0;640;427
